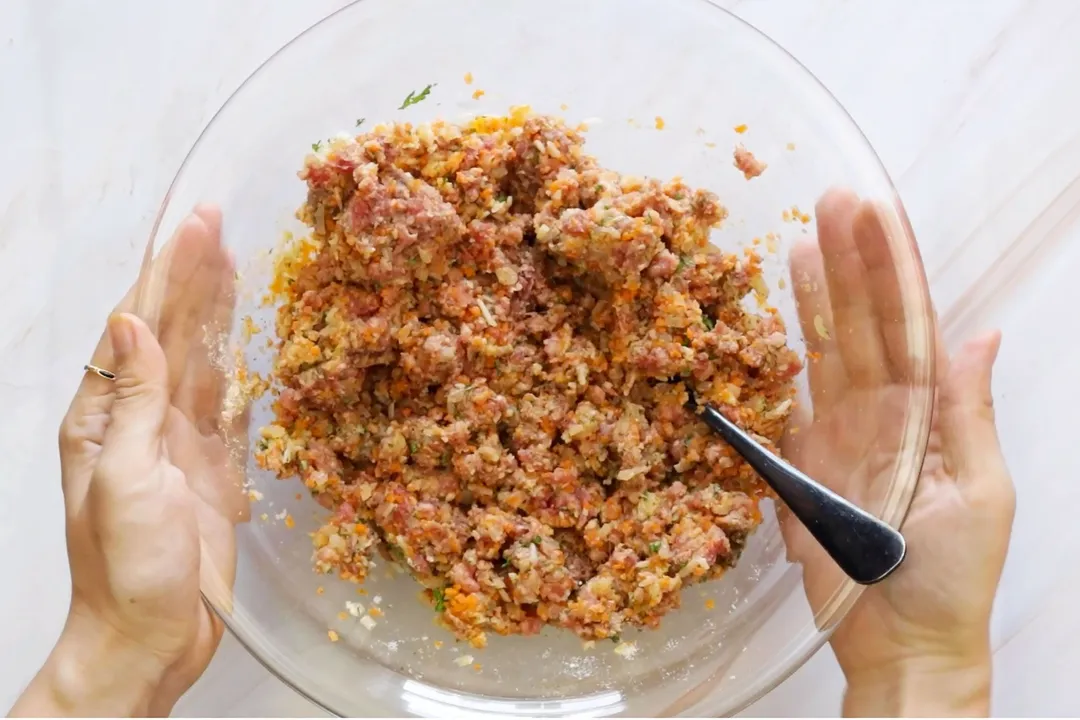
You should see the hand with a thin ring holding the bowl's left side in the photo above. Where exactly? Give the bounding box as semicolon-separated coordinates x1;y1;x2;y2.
12;207;248;716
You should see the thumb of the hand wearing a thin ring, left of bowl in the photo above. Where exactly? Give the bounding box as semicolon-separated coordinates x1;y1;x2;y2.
102;313;168;463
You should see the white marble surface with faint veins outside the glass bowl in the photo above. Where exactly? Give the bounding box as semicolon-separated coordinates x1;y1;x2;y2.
6;0;1080;716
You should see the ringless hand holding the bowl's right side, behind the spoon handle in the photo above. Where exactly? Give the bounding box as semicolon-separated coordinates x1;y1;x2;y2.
782;191;1015;716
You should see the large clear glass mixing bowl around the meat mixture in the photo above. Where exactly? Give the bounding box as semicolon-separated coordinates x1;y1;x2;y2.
132;0;934;717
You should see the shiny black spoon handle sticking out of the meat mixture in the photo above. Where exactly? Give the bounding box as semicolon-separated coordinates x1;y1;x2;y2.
700;406;906;585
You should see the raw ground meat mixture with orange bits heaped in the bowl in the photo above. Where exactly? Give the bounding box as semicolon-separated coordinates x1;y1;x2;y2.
257;109;800;647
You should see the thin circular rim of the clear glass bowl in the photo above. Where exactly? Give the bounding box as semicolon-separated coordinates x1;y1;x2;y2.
136;0;939;717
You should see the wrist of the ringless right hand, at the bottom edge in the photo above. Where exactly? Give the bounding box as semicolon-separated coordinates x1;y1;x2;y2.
843;648;991;717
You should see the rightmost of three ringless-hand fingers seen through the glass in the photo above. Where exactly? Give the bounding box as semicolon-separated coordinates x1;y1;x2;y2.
853;202;917;380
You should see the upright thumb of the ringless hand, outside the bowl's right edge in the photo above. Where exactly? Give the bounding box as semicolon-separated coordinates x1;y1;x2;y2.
937;331;1008;490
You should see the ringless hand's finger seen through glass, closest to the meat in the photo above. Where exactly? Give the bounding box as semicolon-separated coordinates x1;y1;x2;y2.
791;241;847;412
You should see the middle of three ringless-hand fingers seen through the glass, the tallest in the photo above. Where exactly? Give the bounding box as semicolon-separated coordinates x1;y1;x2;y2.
816;185;887;388
